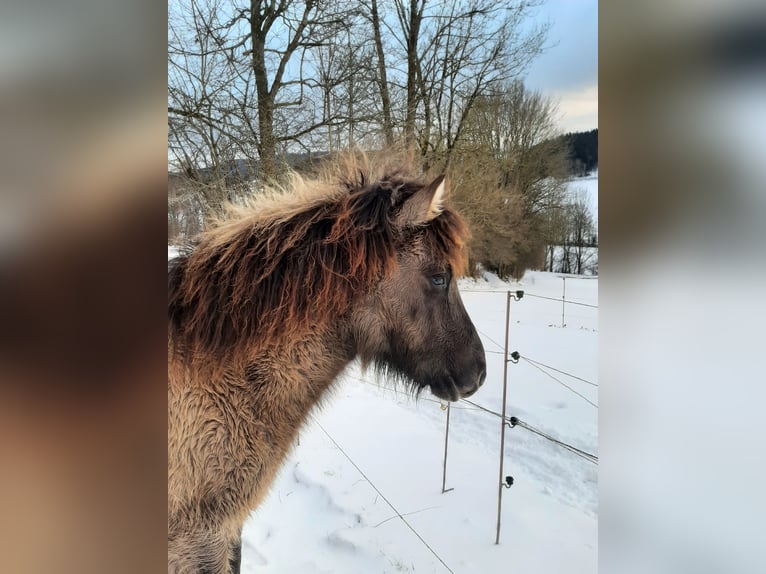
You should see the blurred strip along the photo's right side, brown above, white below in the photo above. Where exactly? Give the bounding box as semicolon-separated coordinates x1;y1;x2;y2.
599;0;766;574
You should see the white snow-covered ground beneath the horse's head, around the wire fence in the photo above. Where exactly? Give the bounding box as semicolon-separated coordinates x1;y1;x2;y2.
236;272;598;574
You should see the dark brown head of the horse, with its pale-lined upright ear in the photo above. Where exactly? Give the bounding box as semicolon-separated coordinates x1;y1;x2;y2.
353;177;486;401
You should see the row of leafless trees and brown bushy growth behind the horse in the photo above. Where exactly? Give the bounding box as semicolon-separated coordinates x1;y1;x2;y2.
168;0;600;275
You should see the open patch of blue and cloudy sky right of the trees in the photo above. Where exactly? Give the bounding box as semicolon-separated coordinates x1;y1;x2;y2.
525;0;598;132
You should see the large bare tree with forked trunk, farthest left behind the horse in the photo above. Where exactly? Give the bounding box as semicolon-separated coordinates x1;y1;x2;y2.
168;0;352;184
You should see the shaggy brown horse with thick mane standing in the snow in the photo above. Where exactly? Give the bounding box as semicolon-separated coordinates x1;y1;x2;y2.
168;158;486;574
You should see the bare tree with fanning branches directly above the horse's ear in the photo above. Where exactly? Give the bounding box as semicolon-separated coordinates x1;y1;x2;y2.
371;0;547;163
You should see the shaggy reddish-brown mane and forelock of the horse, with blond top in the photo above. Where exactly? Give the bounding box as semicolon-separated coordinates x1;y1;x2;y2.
168;156;468;358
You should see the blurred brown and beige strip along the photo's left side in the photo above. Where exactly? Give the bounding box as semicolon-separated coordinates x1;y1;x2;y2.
0;0;167;573
